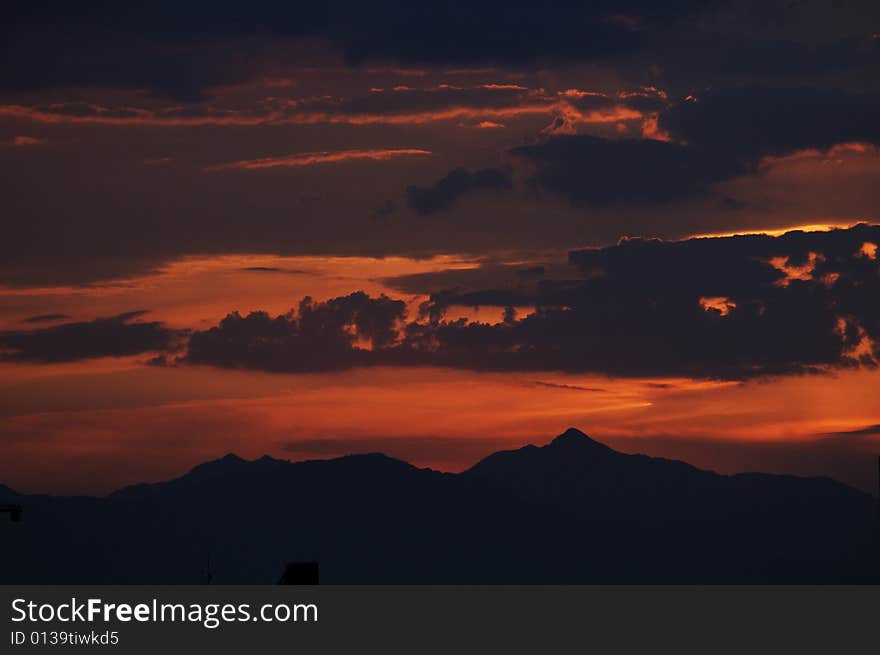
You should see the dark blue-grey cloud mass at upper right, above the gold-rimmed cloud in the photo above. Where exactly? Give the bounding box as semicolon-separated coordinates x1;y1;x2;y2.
511;87;880;209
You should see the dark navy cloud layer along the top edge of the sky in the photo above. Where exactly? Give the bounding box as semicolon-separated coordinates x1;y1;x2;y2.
0;0;705;99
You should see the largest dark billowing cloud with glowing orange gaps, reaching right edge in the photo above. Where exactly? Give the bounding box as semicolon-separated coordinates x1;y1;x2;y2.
177;225;880;379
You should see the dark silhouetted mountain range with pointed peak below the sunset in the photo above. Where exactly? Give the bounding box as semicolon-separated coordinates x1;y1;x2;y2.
0;430;880;583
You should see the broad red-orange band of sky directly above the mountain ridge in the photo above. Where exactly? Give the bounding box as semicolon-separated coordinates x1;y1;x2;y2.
0;364;880;492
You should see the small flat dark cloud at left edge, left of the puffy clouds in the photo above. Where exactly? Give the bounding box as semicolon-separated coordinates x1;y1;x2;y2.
0;311;181;363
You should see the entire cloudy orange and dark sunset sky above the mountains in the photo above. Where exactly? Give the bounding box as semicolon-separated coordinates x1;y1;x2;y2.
0;0;880;493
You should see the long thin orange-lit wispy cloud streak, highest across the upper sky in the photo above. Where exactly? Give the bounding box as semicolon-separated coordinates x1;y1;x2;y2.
0;84;648;129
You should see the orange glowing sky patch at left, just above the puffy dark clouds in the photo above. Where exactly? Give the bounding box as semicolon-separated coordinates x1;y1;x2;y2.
0;254;480;330
